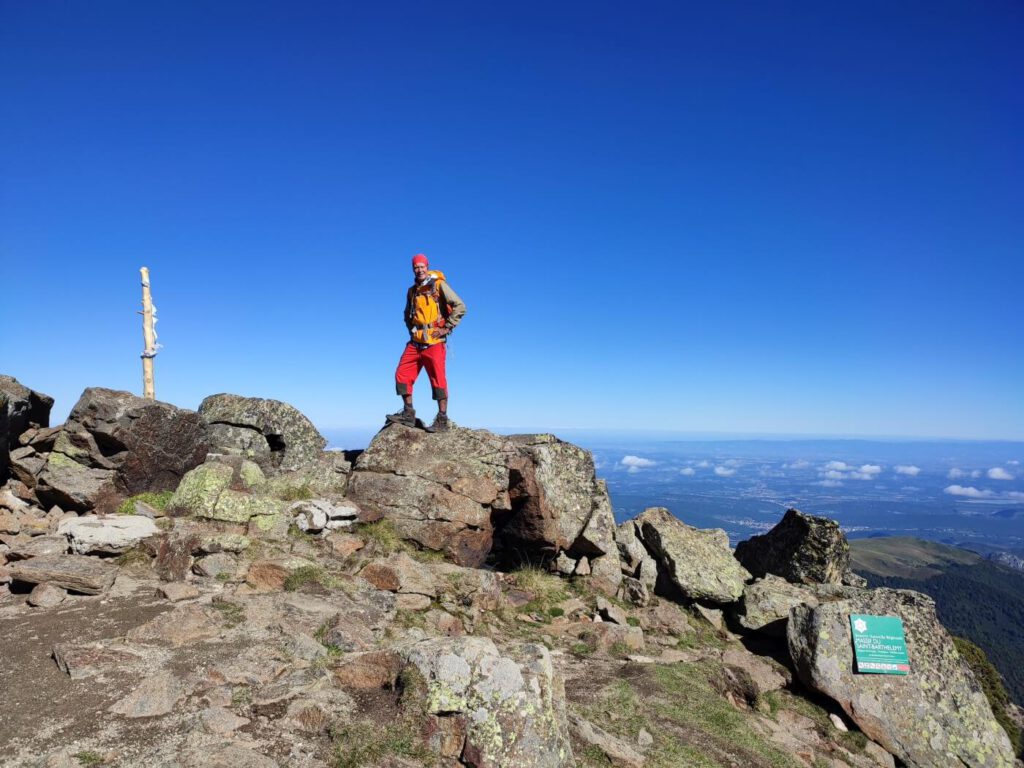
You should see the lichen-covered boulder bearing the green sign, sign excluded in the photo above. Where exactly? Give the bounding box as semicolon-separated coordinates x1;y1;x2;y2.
786;589;1014;768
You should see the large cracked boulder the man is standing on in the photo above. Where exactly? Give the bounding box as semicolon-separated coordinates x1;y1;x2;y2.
347;425;620;573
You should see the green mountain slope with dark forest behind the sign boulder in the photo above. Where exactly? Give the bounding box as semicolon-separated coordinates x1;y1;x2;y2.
850;537;1024;703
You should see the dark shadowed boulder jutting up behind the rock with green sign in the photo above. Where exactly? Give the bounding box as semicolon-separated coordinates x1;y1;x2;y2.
736;509;859;585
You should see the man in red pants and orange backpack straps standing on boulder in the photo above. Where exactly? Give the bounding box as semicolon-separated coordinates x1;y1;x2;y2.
387;253;466;432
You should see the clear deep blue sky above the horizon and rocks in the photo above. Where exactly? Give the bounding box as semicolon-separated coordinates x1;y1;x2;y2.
0;0;1024;439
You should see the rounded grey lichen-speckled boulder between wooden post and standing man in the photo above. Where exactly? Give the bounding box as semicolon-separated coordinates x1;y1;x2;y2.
199;394;327;471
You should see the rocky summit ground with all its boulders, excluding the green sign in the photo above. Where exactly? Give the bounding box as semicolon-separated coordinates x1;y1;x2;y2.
0;381;1014;768
